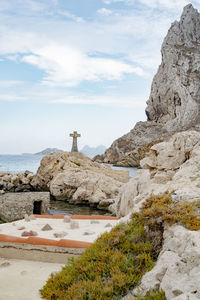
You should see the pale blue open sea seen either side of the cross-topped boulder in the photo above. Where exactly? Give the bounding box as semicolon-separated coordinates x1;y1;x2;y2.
0;154;138;177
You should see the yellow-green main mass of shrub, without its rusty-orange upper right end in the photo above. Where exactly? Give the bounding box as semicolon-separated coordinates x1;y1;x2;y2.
41;214;154;300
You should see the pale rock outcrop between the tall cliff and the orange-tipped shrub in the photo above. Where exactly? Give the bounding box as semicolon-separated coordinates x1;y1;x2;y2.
110;131;200;217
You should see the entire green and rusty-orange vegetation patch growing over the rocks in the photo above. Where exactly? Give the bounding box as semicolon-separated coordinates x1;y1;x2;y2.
41;193;200;300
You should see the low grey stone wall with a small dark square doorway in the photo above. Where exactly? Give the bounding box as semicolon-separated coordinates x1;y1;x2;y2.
0;192;50;222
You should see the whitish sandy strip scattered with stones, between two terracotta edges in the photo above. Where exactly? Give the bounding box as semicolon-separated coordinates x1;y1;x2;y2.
0;218;118;243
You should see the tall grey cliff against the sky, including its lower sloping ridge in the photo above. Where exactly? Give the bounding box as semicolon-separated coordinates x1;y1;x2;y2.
98;4;200;166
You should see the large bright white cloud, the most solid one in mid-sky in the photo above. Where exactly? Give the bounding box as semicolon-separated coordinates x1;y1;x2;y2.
21;45;145;86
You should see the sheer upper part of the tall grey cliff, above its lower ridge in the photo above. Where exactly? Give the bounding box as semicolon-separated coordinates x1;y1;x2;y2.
146;4;200;131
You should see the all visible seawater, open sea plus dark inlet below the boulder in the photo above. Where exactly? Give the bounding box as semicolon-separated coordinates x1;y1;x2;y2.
0;154;138;215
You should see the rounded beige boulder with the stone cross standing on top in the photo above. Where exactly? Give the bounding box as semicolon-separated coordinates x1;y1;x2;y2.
31;152;129;208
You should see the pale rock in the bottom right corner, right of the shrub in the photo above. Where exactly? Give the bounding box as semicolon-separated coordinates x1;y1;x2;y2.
123;225;200;300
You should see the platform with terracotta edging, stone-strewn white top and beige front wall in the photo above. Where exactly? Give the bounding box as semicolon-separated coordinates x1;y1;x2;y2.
0;215;118;263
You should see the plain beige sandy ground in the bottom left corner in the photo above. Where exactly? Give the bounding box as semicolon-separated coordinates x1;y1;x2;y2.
0;258;63;300
